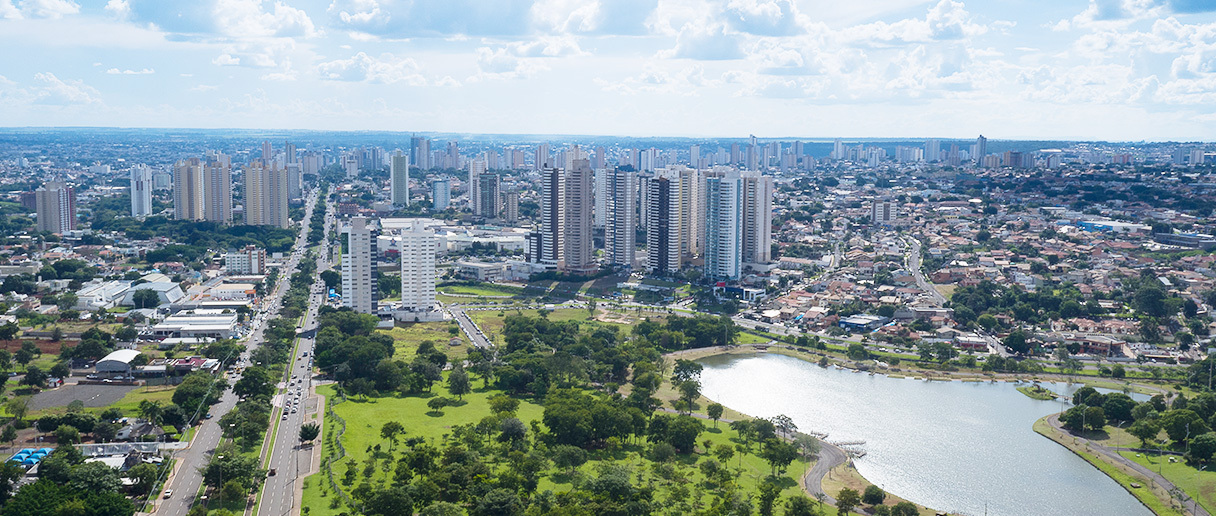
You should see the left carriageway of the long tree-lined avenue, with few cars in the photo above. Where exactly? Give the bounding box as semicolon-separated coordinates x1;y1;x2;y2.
157;191;316;516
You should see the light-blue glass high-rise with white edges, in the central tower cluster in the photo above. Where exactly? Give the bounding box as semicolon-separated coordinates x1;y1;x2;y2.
705;172;743;280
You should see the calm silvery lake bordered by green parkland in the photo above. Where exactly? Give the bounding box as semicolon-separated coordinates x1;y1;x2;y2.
698;354;1152;516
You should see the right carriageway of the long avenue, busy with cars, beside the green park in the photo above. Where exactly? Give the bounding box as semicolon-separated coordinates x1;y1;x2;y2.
254;192;333;516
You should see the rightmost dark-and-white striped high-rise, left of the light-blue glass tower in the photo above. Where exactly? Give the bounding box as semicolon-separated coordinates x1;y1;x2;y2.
642;172;683;274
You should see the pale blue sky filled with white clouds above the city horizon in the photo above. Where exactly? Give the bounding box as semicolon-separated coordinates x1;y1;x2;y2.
0;0;1216;141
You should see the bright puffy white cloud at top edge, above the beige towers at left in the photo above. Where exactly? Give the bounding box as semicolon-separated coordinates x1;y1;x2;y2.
214;0;319;38
